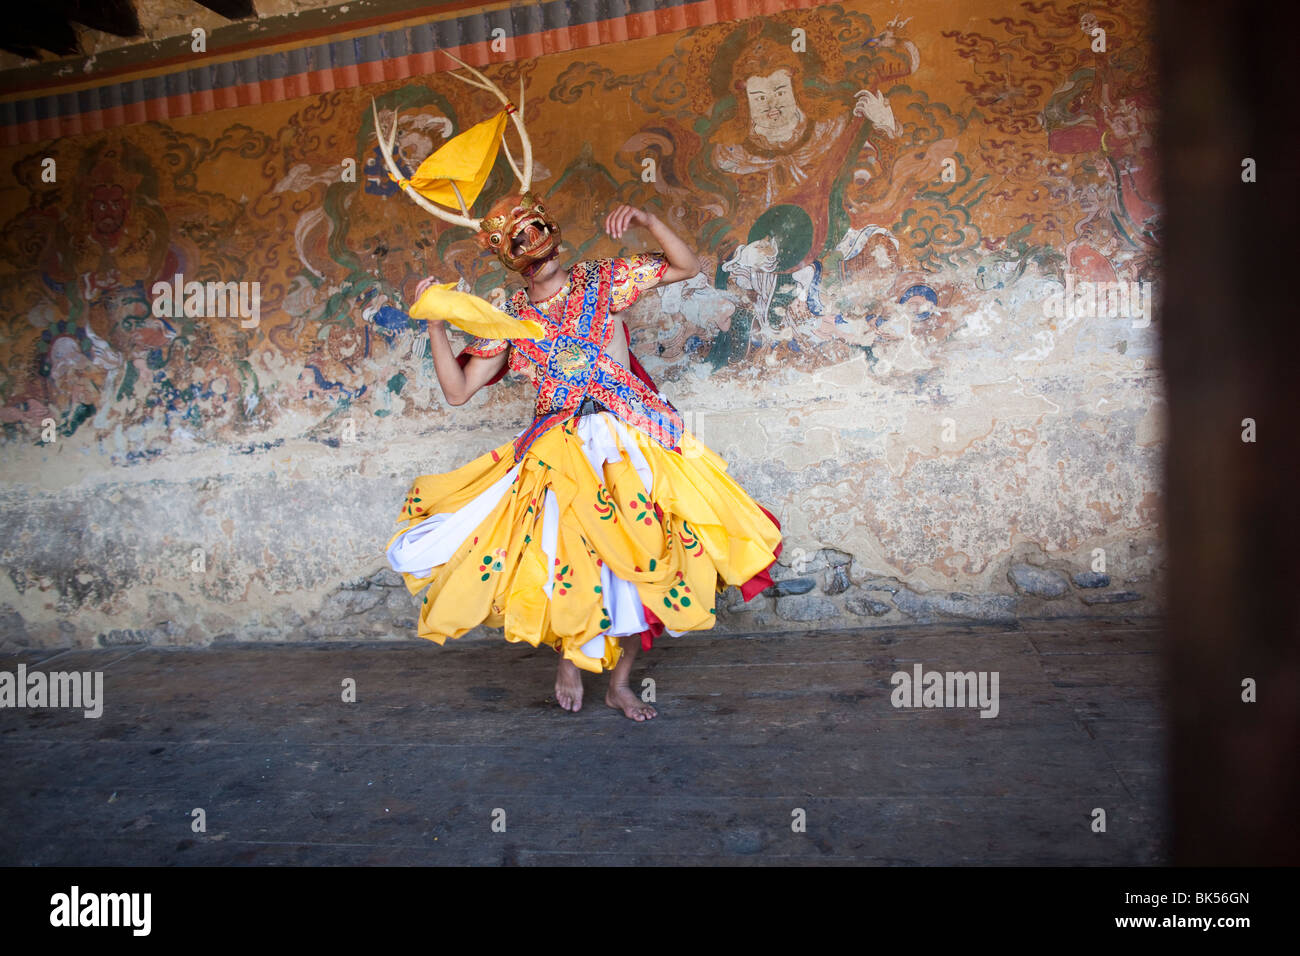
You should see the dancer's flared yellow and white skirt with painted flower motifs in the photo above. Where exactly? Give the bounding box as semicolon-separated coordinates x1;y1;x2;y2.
387;411;781;672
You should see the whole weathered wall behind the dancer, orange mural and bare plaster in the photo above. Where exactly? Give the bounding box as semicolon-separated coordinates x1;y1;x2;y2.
0;1;1164;645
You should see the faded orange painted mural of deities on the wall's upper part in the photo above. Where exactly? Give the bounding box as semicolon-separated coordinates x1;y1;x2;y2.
0;3;1158;447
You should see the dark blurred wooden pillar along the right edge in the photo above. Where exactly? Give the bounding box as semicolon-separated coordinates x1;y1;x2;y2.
1156;0;1300;865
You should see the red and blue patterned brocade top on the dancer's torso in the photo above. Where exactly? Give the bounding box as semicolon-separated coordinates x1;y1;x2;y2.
471;259;683;462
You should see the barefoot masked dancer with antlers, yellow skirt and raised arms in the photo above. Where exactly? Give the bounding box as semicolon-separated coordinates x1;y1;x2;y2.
376;52;781;721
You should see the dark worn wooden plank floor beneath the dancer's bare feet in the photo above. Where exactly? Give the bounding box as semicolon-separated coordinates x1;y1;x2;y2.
0;620;1167;866
